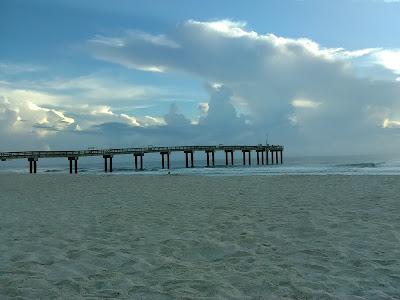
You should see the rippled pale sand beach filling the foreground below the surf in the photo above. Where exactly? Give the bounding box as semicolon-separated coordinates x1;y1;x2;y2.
0;174;400;299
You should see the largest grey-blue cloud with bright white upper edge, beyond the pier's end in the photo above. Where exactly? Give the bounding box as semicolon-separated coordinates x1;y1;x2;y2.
88;20;400;151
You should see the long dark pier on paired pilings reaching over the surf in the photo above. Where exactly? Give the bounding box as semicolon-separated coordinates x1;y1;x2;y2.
0;144;283;174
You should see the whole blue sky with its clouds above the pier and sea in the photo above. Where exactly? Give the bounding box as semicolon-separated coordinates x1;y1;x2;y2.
0;0;400;155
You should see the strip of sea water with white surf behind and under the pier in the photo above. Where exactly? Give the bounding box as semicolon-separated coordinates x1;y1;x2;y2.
0;152;400;176
